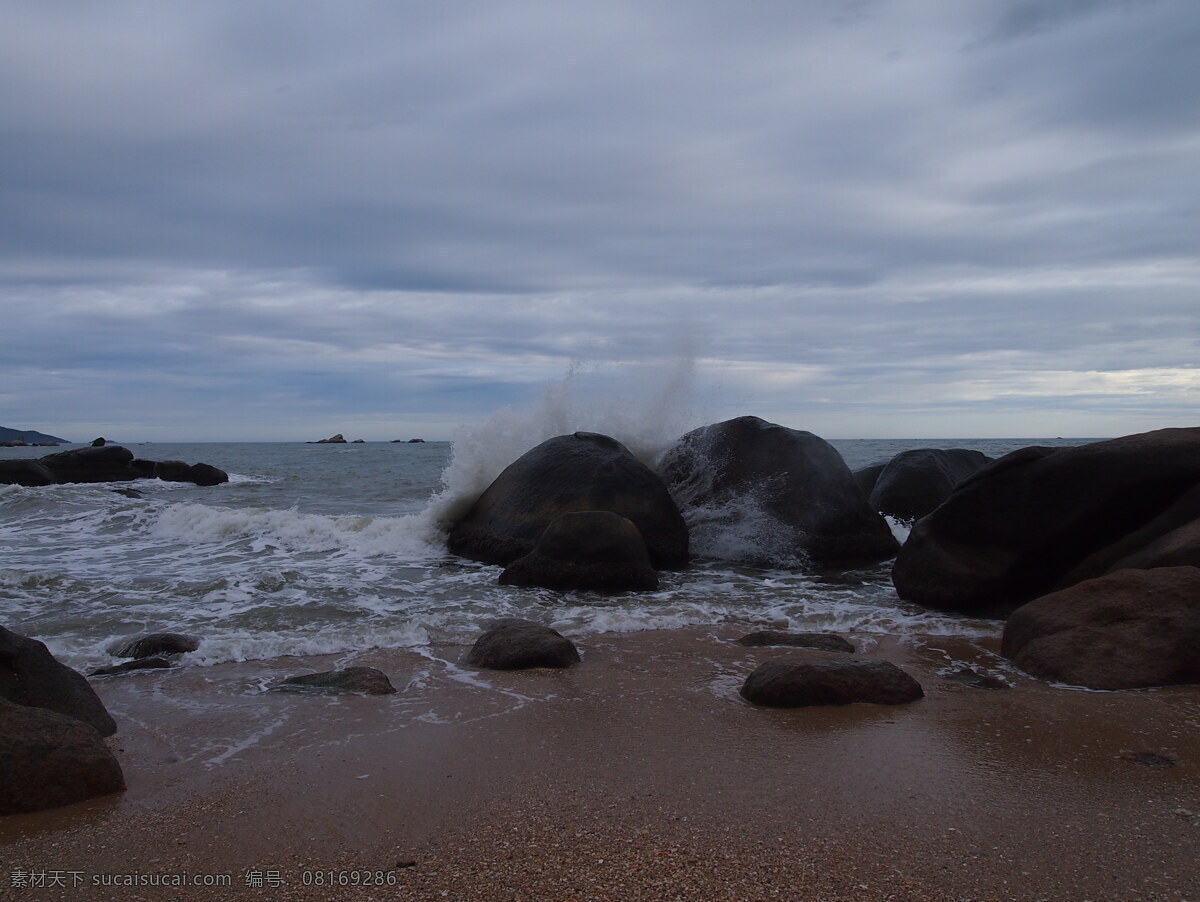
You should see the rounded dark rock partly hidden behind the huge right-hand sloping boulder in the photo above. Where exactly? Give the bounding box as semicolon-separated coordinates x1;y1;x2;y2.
869;447;991;523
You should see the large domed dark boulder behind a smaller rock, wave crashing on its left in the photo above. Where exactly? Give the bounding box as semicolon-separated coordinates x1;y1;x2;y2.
448;432;688;570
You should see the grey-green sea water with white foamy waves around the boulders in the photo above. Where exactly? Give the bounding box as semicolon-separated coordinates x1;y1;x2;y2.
0;431;1084;669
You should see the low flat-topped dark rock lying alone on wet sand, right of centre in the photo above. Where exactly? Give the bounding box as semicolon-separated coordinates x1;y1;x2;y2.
742;657;924;708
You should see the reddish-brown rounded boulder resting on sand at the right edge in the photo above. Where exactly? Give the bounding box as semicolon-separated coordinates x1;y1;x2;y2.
1001;567;1200;690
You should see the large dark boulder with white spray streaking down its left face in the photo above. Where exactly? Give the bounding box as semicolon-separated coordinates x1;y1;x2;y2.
661;416;899;569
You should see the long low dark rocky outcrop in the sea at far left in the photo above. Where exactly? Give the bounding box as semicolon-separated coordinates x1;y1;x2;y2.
0;439;229;486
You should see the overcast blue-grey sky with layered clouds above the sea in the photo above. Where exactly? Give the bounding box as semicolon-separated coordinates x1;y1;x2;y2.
0;0;1200;440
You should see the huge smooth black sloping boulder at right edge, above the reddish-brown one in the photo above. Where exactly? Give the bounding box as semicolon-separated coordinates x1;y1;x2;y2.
892;428;1200;617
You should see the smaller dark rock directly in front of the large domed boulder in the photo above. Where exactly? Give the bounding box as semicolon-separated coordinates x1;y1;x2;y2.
500;511;659;593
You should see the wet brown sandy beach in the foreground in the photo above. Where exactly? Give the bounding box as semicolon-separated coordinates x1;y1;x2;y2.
0;626;1200;902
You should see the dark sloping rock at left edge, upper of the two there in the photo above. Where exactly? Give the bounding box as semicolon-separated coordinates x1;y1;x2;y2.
0;626;116;736
